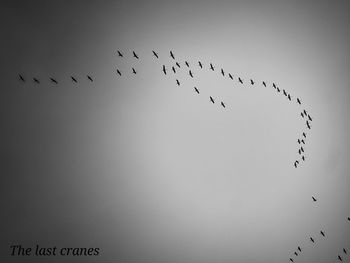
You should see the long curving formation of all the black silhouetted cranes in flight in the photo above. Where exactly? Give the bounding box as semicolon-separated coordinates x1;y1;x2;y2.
18;50;350;262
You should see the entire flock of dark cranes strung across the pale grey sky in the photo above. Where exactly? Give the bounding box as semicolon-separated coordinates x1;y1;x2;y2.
18;50;350;262
